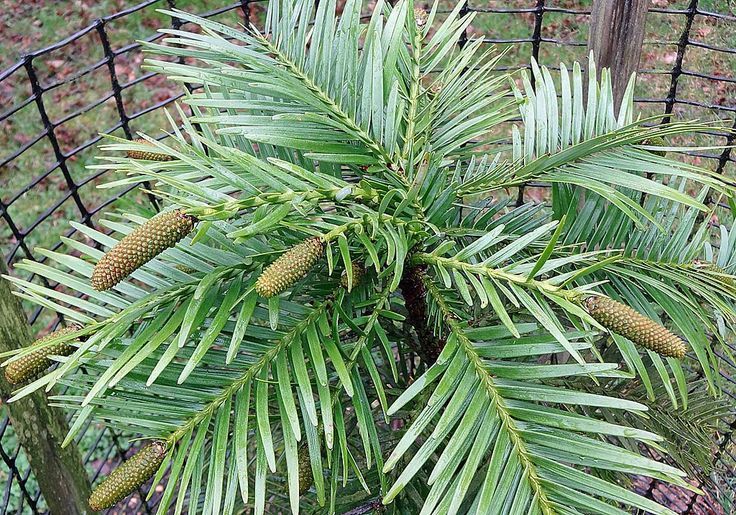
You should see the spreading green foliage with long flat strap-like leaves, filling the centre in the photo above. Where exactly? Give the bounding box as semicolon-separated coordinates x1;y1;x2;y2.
2;0;736;514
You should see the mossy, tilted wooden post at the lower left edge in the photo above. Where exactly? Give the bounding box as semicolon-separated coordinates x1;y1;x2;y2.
0;255;91;515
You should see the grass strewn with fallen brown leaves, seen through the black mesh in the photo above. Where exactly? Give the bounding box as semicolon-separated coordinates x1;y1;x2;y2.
0;0;736;509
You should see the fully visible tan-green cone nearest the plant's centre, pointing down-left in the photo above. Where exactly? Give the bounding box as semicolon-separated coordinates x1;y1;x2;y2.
256;238;325;297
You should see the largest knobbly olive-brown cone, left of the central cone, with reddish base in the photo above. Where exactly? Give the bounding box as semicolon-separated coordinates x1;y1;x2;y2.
91;210;196;291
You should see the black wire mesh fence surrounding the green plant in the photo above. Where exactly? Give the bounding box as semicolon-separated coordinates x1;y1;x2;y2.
0;0;736;514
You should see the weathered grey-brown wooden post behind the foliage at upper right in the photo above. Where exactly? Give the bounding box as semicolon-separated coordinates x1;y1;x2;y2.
588;0;649;110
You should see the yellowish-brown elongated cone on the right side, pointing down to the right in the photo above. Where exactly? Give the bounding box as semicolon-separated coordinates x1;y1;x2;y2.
585;296;686;359
